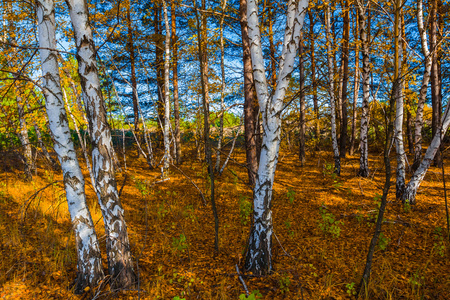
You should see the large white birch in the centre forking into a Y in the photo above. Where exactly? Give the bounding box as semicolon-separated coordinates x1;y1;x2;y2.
245;0;308;275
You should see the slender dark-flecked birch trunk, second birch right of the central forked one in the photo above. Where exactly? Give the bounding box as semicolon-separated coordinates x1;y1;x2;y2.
358;4;370;177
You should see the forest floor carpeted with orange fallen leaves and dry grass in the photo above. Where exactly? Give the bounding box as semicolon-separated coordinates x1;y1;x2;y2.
0;144;450;300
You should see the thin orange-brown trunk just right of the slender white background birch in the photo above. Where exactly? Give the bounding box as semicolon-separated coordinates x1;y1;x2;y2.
170;1;181;164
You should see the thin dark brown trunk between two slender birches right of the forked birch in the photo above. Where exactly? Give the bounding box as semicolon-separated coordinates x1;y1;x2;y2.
339;0;350;158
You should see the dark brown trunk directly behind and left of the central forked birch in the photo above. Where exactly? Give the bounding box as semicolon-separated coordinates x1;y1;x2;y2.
239;0;259;186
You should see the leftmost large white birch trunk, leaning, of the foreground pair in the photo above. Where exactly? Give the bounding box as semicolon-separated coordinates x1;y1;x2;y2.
37;0;104;293
